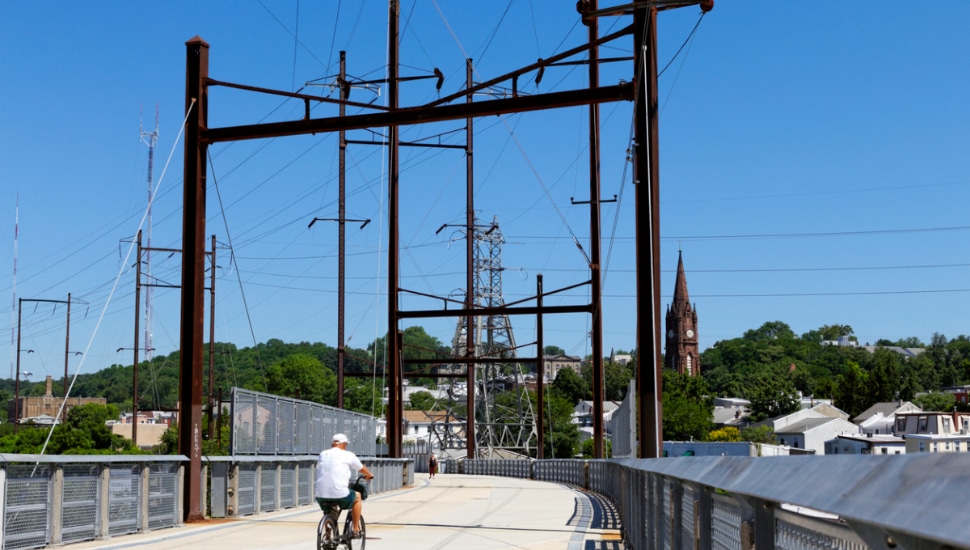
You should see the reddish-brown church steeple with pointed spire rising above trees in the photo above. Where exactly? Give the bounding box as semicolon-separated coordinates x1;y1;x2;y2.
664;251;701;376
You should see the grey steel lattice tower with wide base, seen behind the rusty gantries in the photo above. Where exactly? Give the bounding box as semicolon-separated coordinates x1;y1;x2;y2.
446;218;537;456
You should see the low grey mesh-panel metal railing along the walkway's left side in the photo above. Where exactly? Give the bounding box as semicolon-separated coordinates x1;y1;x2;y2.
0;454;414;550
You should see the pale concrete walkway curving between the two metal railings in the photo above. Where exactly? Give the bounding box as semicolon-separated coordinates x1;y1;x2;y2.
69;474;622;550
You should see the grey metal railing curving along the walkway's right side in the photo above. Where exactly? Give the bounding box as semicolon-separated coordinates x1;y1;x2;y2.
458;453;970;550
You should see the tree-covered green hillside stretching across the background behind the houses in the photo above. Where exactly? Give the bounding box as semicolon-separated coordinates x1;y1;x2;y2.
0;321;970;456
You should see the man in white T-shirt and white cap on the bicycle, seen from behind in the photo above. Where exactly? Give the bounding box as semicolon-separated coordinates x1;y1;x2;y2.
313;434;374;538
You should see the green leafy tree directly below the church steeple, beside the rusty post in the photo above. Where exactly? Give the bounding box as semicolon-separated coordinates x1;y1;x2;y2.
662;370;714;441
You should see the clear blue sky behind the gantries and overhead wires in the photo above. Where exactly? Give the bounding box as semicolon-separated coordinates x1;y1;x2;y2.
0;0;970;388
